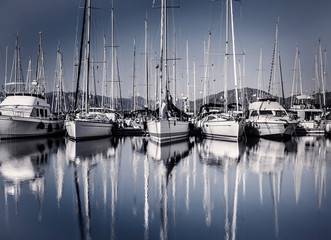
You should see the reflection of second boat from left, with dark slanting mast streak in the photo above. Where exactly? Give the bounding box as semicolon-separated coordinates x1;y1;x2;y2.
66;138;118;239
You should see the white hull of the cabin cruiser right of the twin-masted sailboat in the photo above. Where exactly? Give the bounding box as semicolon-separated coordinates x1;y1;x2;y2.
246;119;296;138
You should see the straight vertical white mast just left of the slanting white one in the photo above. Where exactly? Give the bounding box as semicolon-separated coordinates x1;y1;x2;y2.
224;0;229;112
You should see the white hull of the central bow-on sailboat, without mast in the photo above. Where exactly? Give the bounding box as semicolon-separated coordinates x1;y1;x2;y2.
147;119;189;143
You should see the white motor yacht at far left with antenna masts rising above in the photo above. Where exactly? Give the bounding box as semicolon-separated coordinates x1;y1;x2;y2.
0;33;64;139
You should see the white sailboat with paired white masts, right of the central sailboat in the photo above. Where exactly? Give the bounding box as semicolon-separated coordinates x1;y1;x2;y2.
201;0;245;141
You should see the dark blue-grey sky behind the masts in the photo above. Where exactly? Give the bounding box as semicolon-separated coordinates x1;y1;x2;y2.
0;0;331;97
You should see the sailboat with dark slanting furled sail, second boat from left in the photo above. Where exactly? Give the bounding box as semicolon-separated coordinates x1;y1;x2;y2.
65;0;113;140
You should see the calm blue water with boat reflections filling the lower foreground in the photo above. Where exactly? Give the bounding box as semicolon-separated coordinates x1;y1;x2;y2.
0;137;331;239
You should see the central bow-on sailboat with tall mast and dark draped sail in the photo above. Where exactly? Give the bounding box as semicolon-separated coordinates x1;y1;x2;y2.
147;0;189;143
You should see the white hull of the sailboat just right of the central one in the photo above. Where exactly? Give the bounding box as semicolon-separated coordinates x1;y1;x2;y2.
202;120;244;141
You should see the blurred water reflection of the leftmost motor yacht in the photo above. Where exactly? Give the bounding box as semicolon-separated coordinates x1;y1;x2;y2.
0;138;63;220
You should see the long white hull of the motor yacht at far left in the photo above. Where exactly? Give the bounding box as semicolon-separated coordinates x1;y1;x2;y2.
0;116;64;139
